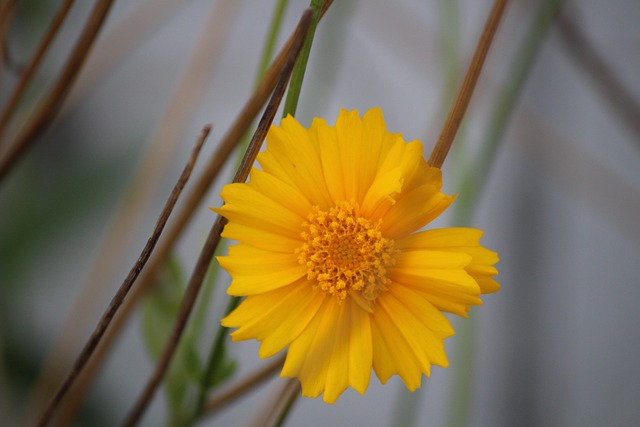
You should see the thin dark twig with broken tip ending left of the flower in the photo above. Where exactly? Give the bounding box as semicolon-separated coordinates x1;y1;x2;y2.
37;125;211;426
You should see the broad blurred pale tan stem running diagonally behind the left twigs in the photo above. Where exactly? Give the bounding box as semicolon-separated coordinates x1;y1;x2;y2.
25;0;237;419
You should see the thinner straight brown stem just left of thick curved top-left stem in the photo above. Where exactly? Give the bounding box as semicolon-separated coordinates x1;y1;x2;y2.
0;0;74;145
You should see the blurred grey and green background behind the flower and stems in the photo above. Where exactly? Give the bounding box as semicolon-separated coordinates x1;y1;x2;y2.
0;0;640;427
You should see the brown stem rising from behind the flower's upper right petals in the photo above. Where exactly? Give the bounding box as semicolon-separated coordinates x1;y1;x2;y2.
428;0;507;168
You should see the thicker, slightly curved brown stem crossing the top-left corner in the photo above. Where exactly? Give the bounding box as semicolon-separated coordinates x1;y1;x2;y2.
0;0;113;182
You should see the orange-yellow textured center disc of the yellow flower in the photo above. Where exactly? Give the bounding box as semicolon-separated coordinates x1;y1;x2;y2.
296;202;395;301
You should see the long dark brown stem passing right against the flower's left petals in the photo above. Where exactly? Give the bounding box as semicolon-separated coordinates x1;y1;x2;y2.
125;10;312;426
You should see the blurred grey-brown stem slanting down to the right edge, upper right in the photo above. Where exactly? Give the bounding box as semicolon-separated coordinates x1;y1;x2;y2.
558;9;640;148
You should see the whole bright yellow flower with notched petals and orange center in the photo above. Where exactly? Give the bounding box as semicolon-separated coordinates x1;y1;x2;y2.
214;109;499;403
